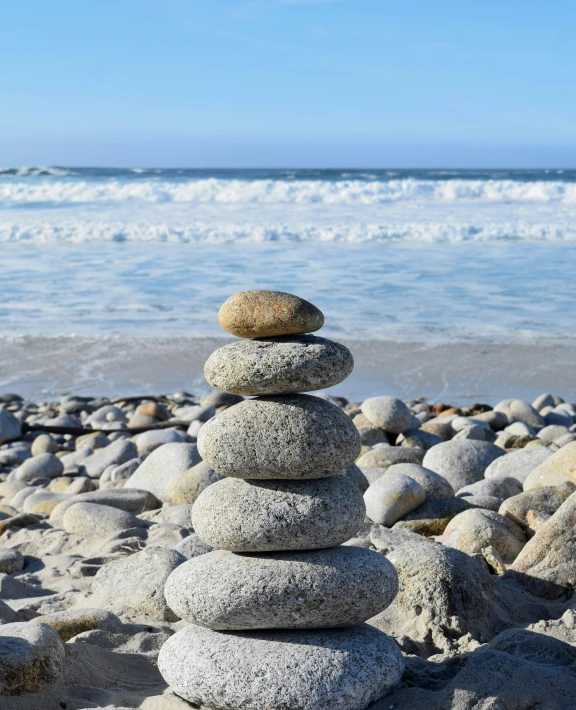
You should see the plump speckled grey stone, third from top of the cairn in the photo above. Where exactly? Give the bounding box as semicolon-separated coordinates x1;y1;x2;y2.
198;394;362;479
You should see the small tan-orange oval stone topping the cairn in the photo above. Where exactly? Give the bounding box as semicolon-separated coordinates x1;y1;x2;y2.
218;291;324;338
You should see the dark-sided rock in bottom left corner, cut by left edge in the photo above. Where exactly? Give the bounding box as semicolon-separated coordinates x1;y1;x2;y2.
0;621;64;696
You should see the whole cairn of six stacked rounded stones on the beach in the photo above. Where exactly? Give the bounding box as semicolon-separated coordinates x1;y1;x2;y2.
159;291;404;710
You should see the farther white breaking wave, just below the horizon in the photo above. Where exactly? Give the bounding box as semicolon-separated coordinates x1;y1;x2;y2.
0;178;576;205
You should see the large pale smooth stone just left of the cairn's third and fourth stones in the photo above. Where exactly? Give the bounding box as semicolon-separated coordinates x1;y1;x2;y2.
124;443;201;503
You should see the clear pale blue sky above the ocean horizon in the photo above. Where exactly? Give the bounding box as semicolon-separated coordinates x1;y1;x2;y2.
0;0;576;167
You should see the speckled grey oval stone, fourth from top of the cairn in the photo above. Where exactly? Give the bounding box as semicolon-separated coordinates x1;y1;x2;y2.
192;476;366;552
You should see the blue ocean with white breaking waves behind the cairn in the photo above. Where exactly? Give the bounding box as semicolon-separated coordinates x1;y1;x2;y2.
0;167;576;400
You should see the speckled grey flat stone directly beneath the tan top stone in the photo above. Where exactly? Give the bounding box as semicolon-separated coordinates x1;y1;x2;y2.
204;335;354;396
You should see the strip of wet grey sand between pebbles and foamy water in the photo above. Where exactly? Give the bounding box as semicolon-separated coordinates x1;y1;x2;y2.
0;336;576;405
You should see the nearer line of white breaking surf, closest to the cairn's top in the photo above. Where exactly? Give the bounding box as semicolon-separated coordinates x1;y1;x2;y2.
0;221;576;244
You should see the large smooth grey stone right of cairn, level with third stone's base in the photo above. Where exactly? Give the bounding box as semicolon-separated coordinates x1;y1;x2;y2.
422;439;505;491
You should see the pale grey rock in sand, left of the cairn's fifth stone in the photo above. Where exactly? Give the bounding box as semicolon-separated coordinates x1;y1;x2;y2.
90;547;186;621
